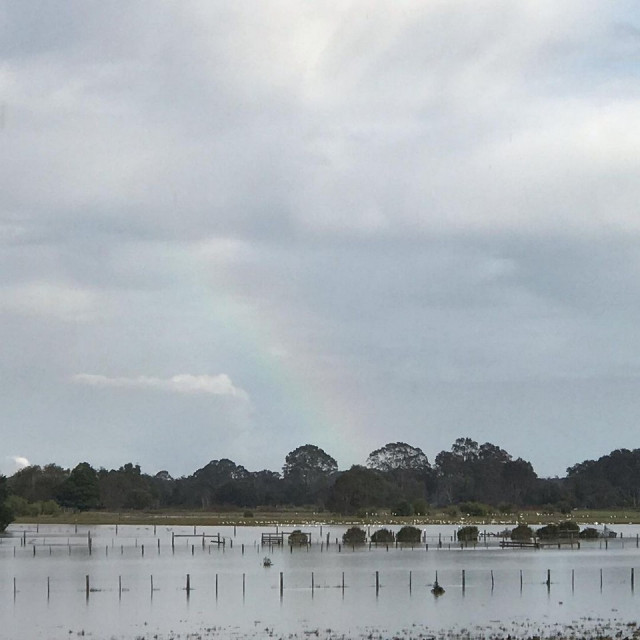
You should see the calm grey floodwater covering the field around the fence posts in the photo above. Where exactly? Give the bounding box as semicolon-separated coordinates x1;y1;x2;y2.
0;525;640;640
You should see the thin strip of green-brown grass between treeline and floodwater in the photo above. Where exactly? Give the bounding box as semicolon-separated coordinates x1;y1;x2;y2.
15;508;640;526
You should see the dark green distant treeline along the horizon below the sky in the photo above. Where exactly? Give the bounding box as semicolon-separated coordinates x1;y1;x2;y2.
0;438;640;529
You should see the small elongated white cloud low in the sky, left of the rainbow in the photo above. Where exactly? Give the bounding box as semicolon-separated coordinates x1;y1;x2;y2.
72;373;249;400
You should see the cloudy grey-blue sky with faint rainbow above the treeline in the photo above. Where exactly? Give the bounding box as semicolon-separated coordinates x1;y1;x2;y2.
0;0;640;477
